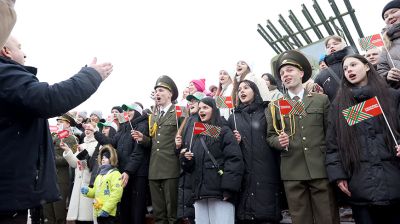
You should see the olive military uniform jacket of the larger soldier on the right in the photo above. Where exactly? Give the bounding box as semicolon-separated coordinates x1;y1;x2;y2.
266;91;329;180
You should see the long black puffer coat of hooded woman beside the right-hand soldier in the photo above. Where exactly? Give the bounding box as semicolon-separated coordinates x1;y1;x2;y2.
229;103;282;222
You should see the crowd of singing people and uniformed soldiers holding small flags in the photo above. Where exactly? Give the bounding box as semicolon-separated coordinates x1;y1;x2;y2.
0;0;400;224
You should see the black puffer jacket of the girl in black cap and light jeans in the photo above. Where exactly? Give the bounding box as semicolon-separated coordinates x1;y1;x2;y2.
183;125;244;200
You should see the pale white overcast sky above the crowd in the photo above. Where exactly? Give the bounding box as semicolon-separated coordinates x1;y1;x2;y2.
13;0;388;118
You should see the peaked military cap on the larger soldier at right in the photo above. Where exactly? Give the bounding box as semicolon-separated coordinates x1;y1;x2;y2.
275;50;312;83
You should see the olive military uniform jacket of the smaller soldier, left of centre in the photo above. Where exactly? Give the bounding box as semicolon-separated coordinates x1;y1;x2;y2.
144;104;180;180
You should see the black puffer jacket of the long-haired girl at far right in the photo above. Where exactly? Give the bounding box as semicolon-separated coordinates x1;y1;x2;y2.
326;89;400;205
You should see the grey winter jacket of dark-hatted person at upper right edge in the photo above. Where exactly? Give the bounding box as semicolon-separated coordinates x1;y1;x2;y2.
377;24;400;89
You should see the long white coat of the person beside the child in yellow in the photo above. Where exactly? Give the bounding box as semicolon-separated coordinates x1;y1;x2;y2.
63;137;98;221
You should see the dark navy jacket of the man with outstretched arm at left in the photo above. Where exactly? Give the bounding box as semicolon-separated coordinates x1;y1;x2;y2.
0;57;102;211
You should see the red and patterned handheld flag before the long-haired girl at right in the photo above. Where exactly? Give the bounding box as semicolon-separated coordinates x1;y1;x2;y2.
342;97;383;126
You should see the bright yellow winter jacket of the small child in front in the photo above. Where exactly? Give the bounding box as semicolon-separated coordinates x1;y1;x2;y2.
86;168;123;217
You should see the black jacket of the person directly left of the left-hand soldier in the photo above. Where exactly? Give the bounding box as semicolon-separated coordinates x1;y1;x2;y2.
94;115;150;177
